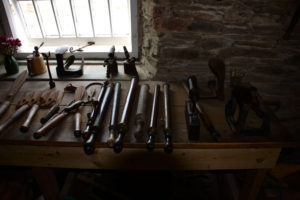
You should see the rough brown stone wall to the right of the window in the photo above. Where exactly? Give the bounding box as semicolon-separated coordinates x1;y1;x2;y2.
140;0;300;138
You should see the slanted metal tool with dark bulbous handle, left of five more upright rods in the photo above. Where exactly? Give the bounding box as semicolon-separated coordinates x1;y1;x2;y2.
83;84;113;155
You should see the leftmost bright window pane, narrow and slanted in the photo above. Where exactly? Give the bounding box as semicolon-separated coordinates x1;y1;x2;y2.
19;1;42;38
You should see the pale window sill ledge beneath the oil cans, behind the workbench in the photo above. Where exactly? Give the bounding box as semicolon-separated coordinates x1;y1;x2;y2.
0;64;150;81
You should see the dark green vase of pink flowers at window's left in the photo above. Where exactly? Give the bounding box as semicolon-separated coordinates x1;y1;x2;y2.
0;35;22;74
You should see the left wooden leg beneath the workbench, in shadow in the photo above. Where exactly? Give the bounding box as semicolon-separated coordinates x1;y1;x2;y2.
32;167;59;200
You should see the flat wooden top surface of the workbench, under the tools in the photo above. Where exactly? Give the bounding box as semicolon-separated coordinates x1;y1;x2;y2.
0;78;292;149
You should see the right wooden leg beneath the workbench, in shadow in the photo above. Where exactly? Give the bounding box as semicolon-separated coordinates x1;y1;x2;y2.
239;169;268;200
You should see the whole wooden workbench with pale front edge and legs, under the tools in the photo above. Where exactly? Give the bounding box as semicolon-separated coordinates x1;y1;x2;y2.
0;78;291;199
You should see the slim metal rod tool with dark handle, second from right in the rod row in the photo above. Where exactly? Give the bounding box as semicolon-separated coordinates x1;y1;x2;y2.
146;84;160;150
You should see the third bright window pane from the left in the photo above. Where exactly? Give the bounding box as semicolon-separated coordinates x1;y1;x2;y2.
53;0;76;37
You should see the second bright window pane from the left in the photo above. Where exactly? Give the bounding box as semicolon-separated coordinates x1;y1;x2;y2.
36;0;59;37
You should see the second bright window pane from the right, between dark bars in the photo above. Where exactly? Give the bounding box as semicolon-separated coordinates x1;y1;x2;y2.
91;0;111;37
